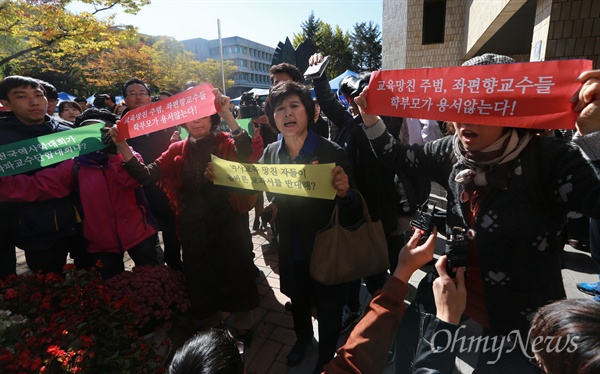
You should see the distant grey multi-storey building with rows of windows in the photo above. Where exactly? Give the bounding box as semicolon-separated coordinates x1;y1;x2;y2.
181;36;275;98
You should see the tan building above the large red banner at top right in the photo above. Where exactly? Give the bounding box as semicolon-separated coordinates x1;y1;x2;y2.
382;0;600;69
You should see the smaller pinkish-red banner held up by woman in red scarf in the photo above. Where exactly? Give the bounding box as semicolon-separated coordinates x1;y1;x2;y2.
117;83;217;141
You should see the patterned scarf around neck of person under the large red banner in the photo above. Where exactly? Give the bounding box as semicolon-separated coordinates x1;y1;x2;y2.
454;129;532;189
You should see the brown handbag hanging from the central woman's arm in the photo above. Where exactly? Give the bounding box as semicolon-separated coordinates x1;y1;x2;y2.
310;191;390;285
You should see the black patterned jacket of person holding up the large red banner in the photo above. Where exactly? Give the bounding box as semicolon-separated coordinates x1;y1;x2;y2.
367;124;600;336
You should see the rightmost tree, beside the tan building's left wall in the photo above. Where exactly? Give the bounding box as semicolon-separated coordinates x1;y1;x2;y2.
350;21;381;72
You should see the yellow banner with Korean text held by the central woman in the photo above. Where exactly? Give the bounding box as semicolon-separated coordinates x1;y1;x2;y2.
212;155;336;200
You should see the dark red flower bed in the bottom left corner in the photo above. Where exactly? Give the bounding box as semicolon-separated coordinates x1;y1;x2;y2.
0;265;165;373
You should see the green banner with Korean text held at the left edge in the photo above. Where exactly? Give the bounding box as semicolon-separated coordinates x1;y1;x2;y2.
0;123;106;177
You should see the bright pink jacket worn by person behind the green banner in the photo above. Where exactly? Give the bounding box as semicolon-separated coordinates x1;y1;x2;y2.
0;153;156;253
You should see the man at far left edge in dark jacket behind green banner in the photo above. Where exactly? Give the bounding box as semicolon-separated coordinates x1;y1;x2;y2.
0;75;85;278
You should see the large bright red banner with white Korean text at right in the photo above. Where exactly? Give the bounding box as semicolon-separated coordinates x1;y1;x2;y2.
367;60;592;129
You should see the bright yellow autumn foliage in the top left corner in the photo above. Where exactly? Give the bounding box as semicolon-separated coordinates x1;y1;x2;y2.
0;0;150;74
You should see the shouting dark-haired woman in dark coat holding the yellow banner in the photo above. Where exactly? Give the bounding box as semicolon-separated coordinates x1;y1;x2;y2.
253;81;361;373
